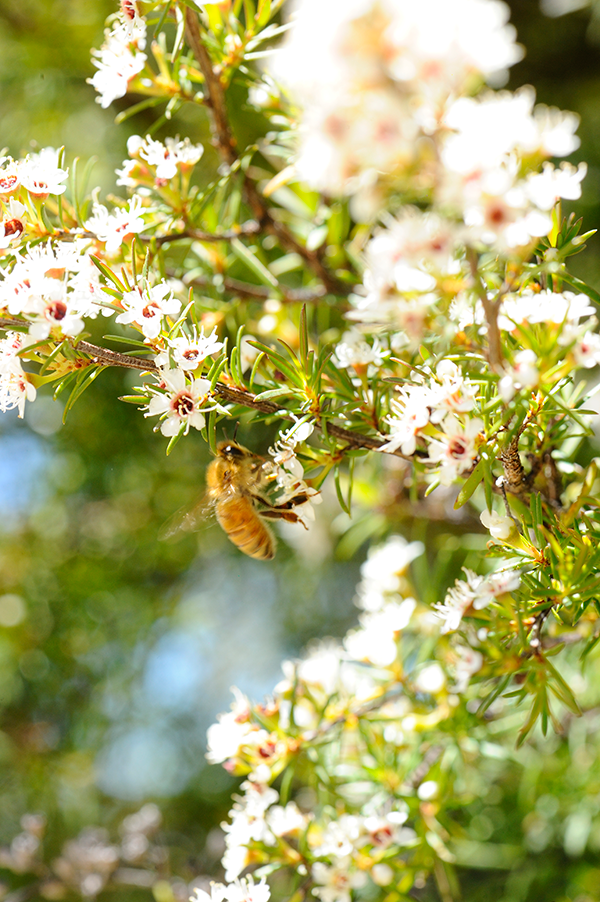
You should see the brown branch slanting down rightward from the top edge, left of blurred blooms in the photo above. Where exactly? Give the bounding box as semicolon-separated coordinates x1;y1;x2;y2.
185;7;348;295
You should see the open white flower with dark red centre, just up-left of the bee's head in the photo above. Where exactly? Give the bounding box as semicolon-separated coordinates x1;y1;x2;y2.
144;369;212;436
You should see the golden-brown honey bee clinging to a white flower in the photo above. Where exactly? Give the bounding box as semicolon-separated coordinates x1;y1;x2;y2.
164;441;309;561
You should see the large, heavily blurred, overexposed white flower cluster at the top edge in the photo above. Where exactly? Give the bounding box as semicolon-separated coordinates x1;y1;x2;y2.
275;0;521;203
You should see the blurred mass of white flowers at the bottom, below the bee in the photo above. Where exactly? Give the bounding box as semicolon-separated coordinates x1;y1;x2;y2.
207;536;520;902
